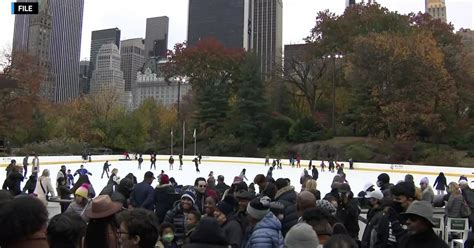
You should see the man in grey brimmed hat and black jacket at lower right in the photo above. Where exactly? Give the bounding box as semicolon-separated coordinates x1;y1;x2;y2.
398;201;448;248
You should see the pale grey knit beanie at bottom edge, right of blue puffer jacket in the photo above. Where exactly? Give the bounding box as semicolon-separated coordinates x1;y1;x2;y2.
285;222;319;248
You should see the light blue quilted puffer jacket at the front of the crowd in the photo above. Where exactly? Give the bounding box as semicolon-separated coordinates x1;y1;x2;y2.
245;212;284;248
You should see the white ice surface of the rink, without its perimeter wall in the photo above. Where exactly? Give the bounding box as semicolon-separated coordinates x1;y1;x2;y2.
0;156;472;196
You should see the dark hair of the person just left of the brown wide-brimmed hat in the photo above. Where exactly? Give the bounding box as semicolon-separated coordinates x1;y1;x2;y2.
48;212;87;248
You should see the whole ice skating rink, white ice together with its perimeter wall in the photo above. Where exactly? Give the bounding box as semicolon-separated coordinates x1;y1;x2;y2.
0;155;474;195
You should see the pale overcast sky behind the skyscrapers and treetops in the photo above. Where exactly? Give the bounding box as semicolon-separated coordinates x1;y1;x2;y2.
0;0;474;58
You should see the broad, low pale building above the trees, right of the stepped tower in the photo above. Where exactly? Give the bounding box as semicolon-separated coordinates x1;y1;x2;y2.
132;68;191;108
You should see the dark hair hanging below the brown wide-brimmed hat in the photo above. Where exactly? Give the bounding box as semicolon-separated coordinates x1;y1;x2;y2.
84;214;118;248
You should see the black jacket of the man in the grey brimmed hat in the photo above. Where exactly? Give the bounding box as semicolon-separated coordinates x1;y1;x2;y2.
398;229;448;248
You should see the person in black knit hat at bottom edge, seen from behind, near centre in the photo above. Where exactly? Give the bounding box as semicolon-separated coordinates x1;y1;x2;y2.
183;216;229;248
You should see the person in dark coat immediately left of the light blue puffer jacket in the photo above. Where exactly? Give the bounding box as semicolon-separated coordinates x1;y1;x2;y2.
214;196;243;248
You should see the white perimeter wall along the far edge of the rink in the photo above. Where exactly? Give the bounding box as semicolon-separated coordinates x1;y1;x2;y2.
0;155;474;177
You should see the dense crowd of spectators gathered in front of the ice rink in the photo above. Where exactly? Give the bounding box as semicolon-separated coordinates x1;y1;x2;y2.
0;156;474;248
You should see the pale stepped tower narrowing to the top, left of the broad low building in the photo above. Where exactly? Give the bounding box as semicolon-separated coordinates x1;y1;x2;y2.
90;43;128;106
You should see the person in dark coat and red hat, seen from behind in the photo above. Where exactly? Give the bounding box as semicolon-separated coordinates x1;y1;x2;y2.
155;174;179;223
